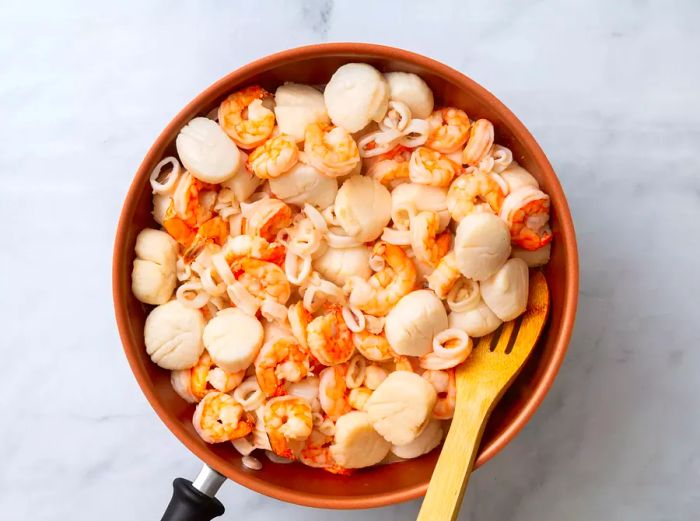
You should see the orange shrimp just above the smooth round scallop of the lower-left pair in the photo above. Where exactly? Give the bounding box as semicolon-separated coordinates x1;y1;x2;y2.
231;257;292;304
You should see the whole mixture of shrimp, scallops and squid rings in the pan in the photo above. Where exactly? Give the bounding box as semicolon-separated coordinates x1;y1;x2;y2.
132;63;552;473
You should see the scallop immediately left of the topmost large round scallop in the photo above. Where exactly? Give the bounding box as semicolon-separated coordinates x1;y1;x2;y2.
275;83;329;142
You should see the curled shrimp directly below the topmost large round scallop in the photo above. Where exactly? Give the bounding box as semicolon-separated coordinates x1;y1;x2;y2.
304;123;360;177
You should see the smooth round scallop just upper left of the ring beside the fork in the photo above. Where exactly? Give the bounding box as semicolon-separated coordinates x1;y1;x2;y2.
384;289;447;356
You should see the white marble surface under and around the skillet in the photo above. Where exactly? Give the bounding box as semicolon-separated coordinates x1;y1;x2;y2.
0;0;700;521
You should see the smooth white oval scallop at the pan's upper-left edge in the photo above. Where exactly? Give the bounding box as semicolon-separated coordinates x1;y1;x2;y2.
175;118;241;183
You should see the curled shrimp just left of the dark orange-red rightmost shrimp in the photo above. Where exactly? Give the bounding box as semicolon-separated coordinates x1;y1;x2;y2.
446;170;506;221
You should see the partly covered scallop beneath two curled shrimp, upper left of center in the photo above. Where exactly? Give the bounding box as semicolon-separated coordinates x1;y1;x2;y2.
270;163;338;210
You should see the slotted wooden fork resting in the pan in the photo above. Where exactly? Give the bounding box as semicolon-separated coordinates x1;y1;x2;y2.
418;271;549;521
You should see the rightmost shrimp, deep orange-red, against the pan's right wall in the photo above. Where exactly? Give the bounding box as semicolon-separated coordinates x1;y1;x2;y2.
501;187;553;251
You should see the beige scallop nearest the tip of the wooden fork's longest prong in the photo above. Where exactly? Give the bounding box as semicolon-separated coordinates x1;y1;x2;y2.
480;259;529;322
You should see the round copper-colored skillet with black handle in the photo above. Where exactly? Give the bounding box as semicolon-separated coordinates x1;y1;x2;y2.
112;43;578;519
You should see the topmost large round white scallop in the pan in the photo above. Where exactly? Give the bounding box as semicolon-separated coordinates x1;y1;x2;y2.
323;63;389;132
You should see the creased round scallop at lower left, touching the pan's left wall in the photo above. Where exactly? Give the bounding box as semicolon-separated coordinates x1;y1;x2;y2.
143;300;204;369
